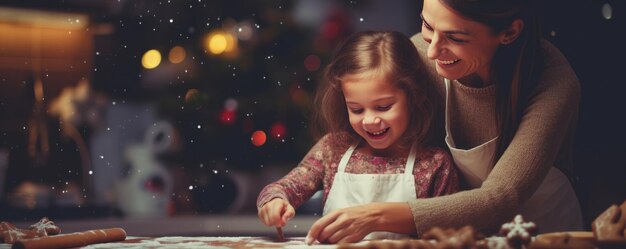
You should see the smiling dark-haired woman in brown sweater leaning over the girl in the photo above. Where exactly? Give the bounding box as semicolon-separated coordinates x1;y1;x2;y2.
307;0;582;243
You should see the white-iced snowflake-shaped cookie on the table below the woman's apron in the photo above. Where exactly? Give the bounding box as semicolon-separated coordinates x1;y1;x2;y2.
500;214;537;248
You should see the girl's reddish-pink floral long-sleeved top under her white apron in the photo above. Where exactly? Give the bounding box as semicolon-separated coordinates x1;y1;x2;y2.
257;136;459;209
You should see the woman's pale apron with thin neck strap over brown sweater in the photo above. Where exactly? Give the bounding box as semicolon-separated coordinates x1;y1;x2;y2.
445;79;583;233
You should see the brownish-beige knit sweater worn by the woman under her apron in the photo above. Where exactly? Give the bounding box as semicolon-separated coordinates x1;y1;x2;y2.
409;34;580;235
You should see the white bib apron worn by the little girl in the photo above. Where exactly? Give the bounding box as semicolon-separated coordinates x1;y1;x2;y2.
324;144;417;240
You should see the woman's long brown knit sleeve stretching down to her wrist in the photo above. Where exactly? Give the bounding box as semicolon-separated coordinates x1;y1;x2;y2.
409;34;580;235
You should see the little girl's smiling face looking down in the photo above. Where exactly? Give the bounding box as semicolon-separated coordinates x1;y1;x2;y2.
341;74;410;155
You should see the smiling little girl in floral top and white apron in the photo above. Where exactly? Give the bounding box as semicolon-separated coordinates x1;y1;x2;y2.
257;32;458;243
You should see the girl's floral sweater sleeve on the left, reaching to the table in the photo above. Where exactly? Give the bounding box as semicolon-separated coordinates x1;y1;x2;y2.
257;135;330;209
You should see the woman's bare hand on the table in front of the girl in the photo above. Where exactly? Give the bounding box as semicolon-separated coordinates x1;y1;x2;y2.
305;204;382;245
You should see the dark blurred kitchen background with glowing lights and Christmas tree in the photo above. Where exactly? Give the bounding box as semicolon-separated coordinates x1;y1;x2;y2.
0;0;626;232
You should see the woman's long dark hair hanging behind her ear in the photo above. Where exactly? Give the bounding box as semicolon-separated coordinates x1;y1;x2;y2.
439;0;542;162
